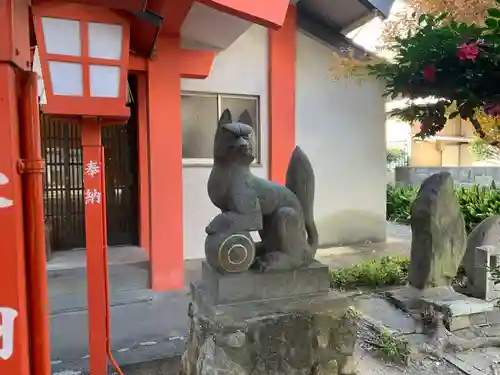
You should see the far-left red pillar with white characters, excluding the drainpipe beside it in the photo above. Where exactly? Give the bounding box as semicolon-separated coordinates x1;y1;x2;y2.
0;0;31;375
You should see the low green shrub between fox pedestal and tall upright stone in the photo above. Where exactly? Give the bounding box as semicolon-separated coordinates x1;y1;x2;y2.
330;257;410;289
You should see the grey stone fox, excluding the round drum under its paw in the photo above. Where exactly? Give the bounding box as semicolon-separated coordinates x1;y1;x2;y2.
206;109;318;271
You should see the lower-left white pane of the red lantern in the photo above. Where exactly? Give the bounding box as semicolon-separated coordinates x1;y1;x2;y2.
49;61;83;96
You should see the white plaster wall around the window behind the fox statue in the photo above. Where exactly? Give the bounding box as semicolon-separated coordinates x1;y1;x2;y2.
181;25;269;259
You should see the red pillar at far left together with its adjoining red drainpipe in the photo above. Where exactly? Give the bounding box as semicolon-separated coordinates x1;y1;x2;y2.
0;0;50;375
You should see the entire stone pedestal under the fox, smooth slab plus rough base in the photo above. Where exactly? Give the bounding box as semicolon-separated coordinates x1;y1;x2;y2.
181;263;358;375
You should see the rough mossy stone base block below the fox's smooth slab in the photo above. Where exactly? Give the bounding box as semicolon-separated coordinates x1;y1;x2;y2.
180;294;359;375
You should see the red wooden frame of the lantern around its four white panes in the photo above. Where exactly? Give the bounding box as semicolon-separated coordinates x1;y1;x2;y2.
32;3;130;119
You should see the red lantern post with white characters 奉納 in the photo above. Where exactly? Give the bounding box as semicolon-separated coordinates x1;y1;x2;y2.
82;118;108;375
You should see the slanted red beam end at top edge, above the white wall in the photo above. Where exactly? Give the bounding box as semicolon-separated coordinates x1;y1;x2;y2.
198;0;290;29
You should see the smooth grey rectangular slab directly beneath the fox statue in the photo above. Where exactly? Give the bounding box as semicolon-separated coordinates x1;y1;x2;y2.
197;261;330;305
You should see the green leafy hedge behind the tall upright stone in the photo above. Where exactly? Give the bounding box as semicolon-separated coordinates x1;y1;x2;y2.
387;184;500;232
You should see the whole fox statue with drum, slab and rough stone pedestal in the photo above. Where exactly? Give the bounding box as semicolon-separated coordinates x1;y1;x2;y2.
180;110;358;375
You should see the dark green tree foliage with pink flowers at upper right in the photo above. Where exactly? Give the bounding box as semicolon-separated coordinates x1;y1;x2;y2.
350;0;500;145
